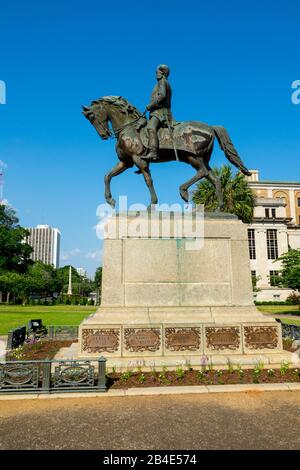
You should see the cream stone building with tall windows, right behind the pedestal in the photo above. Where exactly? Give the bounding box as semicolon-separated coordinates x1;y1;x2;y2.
247;170;300;301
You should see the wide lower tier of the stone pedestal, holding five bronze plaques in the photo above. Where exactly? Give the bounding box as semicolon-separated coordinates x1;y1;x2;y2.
78;306;290;368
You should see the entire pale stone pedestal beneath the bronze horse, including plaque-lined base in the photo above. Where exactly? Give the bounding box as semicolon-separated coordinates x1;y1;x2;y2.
79;211;288;367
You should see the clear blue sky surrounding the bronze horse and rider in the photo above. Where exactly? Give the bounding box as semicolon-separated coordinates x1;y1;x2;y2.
0;0;300;274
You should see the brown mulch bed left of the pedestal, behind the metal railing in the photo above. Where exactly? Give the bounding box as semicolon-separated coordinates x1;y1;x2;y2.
6;340;75;361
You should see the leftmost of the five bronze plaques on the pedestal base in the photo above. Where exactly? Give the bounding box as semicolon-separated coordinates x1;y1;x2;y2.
82;328;120;353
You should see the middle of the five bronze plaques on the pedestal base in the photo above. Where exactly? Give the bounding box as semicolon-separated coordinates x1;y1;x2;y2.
165;327;201;351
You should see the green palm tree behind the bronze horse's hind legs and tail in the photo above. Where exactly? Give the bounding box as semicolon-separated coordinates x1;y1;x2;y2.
193;165;255;224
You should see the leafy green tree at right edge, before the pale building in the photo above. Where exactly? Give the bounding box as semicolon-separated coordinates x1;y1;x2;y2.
273;249;300;291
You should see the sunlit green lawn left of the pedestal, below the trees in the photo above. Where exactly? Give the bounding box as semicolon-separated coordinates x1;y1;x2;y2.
0;305;97;335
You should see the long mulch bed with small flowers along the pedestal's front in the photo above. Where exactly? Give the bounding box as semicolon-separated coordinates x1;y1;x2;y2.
107;369;300;389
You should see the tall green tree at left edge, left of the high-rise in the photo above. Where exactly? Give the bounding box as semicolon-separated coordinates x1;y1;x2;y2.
0;205;33;273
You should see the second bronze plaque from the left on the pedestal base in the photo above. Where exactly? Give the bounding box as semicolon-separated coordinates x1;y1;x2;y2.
124;328;161;352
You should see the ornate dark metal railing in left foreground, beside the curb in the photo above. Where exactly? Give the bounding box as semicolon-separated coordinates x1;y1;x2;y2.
0;357;107;394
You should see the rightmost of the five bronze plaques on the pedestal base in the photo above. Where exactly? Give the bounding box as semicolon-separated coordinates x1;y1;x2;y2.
244;326;279;349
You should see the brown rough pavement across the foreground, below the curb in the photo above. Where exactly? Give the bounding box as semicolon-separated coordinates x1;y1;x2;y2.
0;390;300;450
